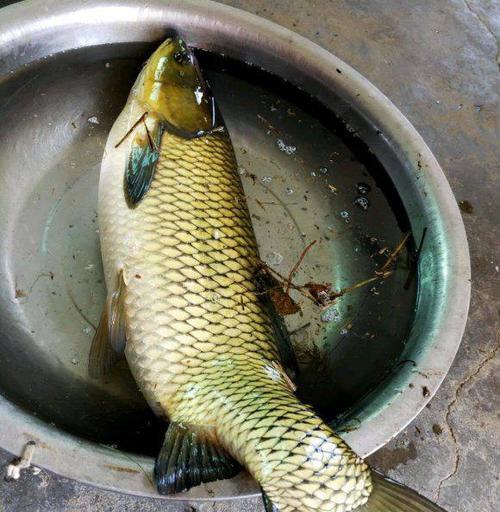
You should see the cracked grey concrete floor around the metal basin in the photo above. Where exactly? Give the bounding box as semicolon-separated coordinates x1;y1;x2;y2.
0;0;500;512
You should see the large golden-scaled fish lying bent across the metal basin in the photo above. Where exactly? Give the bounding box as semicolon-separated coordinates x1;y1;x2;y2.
89;35;450;512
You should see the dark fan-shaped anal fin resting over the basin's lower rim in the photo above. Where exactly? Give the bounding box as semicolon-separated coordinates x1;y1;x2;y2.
155;422;241;494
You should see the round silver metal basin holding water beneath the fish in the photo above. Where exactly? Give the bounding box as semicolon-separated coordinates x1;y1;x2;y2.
0;0;470;500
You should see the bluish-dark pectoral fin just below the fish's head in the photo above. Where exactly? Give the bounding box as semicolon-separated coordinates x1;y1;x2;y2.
124;116;163;207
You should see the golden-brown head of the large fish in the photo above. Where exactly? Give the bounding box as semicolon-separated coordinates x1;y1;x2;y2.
133;36;216;137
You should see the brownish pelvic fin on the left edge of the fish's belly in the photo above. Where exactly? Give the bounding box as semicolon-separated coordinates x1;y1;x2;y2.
88;270;126;379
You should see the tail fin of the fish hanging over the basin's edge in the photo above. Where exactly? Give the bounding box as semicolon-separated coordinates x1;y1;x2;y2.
356;471;446;512
